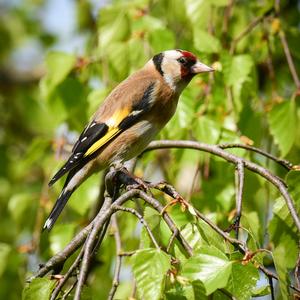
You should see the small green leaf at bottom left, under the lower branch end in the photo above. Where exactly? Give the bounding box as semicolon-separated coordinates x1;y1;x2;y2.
22;278;55;300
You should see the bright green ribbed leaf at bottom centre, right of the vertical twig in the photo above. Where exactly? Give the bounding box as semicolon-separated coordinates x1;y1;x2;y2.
131;248;171;300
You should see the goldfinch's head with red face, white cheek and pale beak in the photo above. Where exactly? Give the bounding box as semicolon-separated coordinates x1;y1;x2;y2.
150;49;214;93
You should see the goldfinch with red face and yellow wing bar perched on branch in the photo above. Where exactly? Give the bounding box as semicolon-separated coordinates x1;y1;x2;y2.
43;49;214;230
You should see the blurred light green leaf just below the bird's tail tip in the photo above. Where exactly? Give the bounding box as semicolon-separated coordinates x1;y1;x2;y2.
49;224;75;254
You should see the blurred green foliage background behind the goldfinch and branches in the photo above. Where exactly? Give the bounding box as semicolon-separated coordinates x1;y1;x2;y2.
0;0;300;300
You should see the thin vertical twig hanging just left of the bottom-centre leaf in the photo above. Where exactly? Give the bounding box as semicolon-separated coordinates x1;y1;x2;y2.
108;215;122;300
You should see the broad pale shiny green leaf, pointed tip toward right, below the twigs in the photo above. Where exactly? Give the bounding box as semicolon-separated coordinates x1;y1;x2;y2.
182;246;232;295
